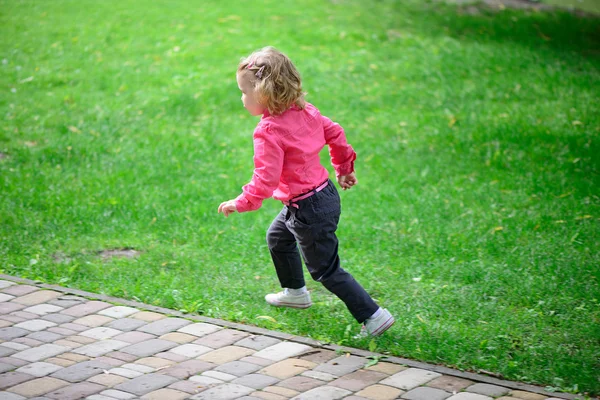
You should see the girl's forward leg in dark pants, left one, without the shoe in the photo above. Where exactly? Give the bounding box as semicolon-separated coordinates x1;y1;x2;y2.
267;207;306;289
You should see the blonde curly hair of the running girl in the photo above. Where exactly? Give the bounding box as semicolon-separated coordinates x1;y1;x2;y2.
237;46;305;115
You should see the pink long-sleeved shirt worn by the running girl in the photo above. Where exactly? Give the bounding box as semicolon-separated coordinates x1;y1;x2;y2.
235;103;356;212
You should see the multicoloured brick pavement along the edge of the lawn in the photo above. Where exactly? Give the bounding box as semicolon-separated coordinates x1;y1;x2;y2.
0;275;592;400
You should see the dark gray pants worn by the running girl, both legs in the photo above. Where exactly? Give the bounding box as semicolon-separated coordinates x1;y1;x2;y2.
267;180;379;323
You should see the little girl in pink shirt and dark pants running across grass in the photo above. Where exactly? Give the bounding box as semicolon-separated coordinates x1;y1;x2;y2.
218;47;394;336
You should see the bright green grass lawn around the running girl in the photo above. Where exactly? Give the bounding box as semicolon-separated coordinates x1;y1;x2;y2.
0;0;600;393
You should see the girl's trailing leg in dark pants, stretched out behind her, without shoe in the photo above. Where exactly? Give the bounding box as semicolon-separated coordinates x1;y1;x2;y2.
286;182;379;323
